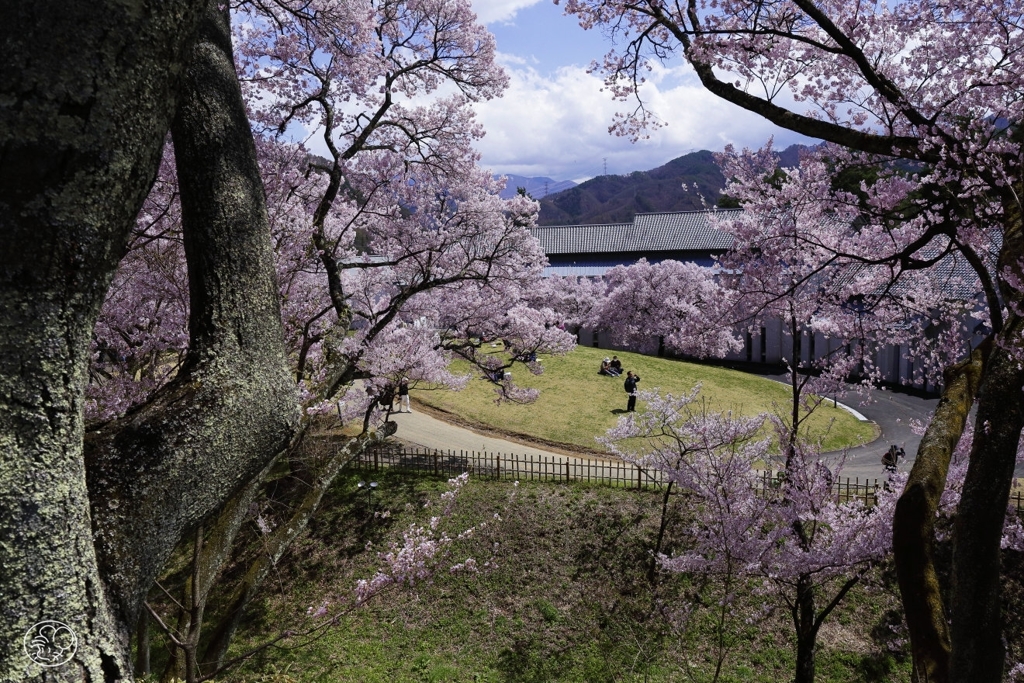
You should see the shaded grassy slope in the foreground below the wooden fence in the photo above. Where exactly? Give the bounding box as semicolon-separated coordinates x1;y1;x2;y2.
224;472;910;683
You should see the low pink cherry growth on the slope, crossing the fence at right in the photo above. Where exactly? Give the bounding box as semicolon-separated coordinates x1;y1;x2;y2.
603;385;895;683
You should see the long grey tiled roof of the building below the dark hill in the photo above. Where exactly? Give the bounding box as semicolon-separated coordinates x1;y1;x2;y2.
532;211;732;256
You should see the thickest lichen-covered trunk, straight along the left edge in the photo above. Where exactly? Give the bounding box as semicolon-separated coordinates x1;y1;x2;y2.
0;0;204;681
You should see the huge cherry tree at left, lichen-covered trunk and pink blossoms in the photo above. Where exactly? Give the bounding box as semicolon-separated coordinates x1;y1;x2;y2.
0;1;568;680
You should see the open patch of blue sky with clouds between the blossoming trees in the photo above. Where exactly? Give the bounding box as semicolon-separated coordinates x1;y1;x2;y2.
473;0;806;182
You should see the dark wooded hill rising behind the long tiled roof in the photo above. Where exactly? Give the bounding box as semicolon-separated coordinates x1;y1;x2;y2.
536;144;815;225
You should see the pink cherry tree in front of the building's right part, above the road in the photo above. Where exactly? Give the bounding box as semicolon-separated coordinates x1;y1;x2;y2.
710;143;970;462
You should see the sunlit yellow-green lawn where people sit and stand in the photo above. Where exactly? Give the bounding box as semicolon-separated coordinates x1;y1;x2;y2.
413;346;874;451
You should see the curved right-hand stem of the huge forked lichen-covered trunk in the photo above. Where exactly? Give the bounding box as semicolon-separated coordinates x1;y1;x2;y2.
87;0;299;643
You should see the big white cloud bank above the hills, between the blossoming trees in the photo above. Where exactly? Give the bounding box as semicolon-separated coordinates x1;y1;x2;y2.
475;58;804;181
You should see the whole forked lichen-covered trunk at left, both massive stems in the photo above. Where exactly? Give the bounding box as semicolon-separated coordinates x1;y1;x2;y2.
0;0;298;681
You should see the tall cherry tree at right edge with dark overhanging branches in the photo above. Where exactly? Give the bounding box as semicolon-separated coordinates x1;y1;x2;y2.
564;0;1024;681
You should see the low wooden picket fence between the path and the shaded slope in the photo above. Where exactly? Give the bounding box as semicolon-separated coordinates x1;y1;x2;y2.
349;446;1024;514
